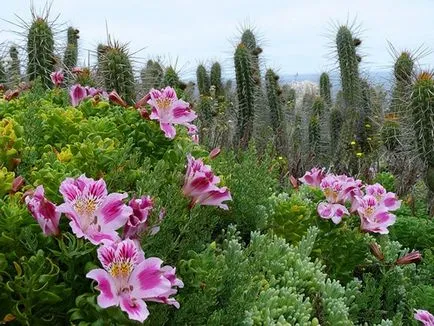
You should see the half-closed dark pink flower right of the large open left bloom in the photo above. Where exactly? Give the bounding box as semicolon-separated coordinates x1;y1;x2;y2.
123;196;154;239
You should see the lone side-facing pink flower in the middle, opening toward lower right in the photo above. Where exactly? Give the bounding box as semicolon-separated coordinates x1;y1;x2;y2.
182;154;232;209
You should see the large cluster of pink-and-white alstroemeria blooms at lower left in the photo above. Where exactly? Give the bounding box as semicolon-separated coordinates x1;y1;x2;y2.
25;175;183;322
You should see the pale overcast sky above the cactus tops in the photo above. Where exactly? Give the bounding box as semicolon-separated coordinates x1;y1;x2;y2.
0;0;434;76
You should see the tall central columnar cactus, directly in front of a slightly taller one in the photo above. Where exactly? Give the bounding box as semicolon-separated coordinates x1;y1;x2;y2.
234;43;255;146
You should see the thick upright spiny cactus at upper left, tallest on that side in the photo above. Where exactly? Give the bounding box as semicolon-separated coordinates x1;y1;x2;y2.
27;17;55;88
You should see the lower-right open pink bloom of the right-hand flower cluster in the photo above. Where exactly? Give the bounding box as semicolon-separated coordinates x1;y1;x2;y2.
357;195;396;234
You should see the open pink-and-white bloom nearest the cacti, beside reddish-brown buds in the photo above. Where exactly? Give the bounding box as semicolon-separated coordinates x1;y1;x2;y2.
148;86;197;139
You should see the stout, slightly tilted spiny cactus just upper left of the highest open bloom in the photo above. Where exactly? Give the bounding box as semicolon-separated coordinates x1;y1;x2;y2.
98;42;135;103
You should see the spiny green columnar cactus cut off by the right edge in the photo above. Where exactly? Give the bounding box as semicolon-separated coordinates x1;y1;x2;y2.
411;72;434;216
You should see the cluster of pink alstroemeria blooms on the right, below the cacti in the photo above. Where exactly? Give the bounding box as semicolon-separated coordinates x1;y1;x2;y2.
299;168;401;234
